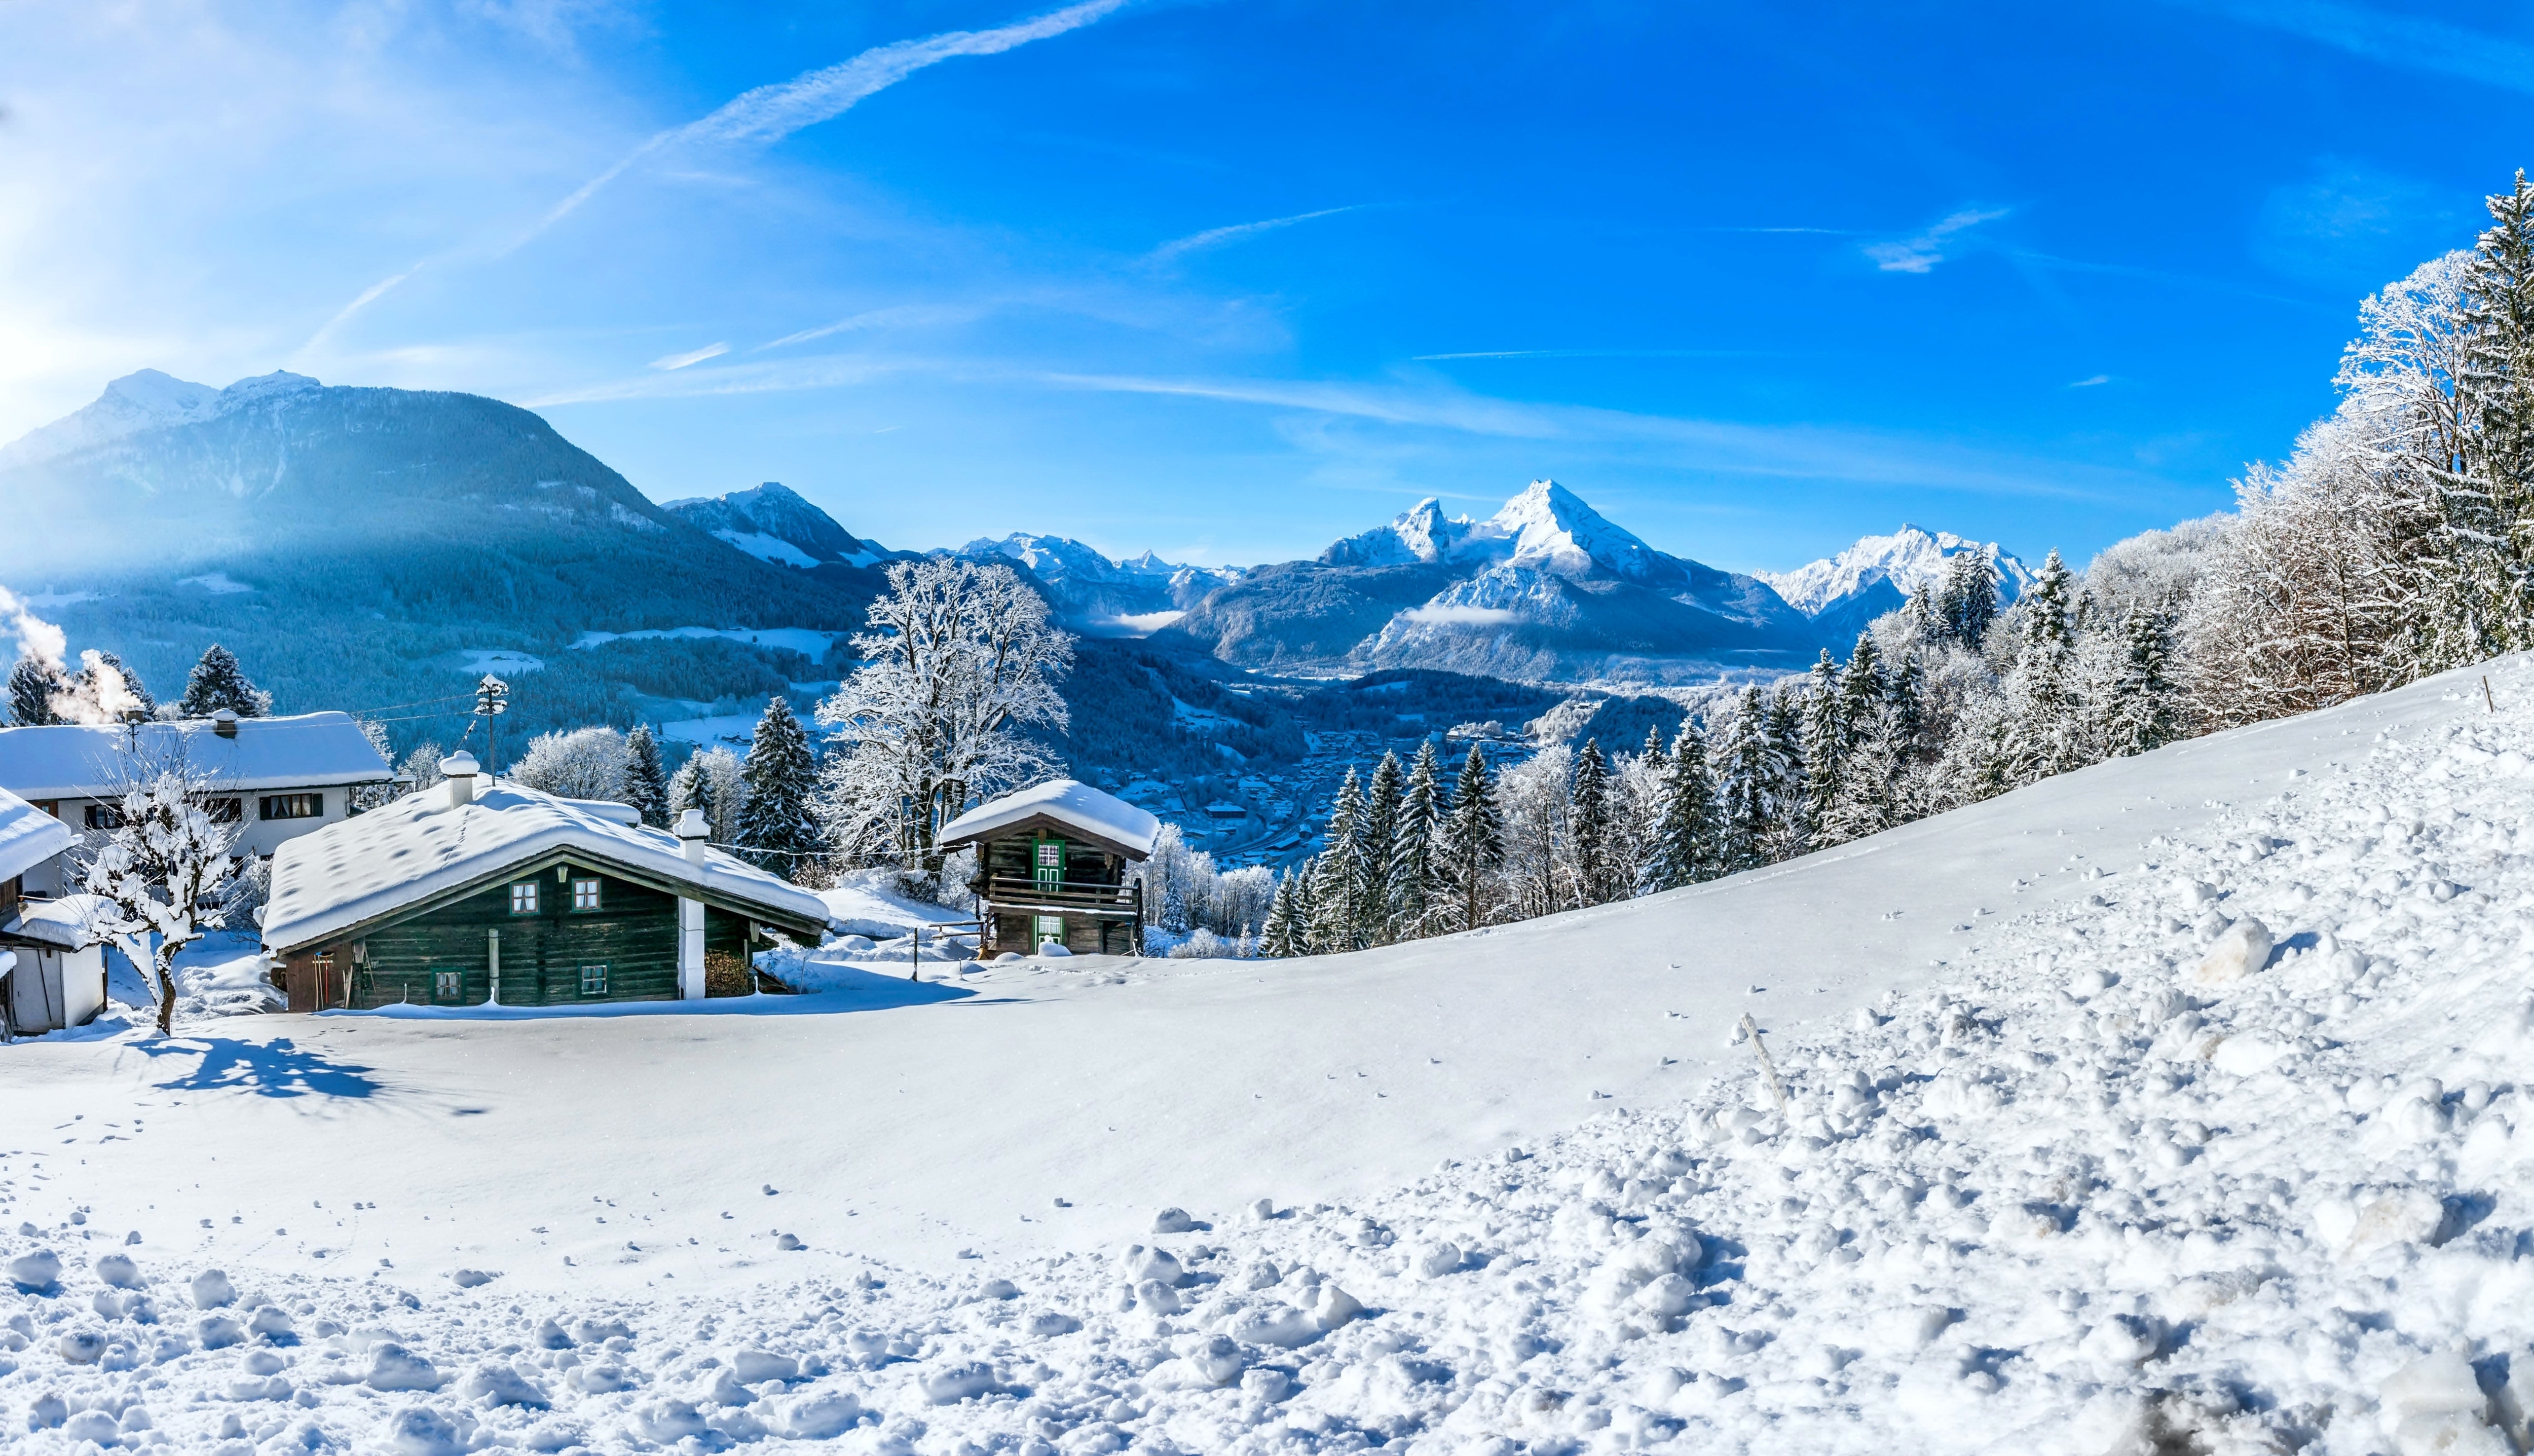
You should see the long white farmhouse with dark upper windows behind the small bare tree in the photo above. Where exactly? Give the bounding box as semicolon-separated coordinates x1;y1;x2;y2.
0;712;395;897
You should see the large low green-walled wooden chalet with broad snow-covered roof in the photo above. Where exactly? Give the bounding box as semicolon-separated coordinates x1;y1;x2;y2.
264;755;826;1011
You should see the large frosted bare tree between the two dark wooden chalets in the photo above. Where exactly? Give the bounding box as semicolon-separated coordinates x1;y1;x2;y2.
818;557;1074;871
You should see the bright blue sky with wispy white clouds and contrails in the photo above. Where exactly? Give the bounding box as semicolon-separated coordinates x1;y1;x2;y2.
0;0;2534;570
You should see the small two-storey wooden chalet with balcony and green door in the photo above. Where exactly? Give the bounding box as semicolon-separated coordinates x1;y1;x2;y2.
940;777;1161;955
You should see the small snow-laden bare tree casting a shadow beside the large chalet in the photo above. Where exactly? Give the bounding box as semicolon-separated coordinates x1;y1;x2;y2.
84;734;243;1036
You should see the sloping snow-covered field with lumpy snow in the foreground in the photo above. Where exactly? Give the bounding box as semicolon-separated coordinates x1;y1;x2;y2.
0;661;2534;1456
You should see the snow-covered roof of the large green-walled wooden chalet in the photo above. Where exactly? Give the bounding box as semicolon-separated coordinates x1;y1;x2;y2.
264;782;826;950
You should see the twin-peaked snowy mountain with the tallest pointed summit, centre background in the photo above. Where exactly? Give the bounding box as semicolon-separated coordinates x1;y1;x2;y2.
1171;481;1814;681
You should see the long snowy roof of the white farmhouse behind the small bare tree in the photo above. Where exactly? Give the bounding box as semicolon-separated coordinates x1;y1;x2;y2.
0;712;395;798
